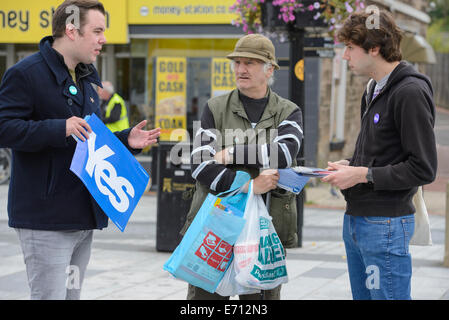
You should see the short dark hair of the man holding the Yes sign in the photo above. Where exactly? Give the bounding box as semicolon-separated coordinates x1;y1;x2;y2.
52;0;106;39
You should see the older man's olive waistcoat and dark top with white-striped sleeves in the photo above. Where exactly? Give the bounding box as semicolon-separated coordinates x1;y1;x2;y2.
181;89;303;247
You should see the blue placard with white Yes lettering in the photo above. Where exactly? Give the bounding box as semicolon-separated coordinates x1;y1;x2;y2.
70;114;150;232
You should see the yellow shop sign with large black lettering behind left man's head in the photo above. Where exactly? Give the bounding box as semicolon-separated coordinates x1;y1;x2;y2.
0;0;128;43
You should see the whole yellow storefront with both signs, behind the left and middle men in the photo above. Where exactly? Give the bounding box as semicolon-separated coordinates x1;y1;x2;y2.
0;0;252;144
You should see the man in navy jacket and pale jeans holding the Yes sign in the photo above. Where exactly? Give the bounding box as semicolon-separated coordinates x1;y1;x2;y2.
0;0;160;299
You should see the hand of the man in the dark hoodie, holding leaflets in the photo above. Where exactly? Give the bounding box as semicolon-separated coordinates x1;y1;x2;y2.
321;162;368;190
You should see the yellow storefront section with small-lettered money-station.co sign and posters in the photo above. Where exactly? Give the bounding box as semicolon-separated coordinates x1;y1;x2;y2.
123;0;248;141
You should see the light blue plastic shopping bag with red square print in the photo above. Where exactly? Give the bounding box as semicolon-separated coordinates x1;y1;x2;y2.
164;171;250;293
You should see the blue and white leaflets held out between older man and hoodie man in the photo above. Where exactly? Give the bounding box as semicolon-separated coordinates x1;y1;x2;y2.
278;167;331;194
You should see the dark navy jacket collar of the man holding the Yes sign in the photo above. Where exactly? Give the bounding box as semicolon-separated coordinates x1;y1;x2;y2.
39;36;101;86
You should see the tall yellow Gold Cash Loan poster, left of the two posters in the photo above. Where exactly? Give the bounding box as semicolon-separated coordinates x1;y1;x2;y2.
156;57;187;141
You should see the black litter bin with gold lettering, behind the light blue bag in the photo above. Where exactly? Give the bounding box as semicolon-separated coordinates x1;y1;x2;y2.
156;143;195;252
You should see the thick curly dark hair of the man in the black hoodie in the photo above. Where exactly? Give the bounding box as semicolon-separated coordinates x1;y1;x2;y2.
337;10;402;62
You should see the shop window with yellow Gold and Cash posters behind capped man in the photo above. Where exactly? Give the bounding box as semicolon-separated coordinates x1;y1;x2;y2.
146;39;237;141
